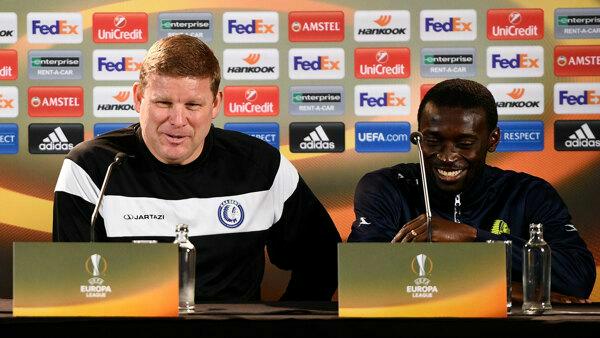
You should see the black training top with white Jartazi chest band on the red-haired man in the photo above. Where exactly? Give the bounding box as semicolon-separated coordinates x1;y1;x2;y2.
52;124;341;301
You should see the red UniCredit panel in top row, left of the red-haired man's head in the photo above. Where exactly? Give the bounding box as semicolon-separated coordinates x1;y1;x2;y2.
92;13;148;43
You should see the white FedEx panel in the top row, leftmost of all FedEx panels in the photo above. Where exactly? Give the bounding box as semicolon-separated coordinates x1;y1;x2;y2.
27;12;83;43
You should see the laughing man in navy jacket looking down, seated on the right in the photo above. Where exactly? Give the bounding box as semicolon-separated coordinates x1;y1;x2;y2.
348;79;596;298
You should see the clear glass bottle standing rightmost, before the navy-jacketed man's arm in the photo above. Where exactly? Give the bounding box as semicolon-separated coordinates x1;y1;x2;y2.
523;224;552;315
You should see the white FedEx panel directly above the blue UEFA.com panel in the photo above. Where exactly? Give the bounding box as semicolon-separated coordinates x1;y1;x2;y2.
354;85;410;116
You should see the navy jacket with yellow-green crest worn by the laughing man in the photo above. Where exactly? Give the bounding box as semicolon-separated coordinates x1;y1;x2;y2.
348;164;596;298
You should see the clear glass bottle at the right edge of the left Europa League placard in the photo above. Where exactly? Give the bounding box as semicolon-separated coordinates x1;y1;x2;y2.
173;224;196;313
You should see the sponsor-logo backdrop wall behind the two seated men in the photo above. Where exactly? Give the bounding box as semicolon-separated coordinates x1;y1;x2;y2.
0;0;600;300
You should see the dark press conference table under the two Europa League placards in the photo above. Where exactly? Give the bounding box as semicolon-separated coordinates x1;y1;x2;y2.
0;299;600;338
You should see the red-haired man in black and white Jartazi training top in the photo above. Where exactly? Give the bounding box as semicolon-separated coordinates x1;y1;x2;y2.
52;35;341;301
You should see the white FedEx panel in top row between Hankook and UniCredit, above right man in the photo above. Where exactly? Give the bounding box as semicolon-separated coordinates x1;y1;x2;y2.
420;9;477;41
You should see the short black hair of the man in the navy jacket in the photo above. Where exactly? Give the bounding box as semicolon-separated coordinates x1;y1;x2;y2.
417;79;498;132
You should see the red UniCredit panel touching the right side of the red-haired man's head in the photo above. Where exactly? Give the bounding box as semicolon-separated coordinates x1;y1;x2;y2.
223;86;279;116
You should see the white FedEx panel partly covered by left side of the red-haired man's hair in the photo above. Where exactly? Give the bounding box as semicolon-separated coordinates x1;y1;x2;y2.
93;49;146;81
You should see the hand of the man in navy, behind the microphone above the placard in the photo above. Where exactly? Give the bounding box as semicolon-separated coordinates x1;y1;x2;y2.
392;214;477;243
